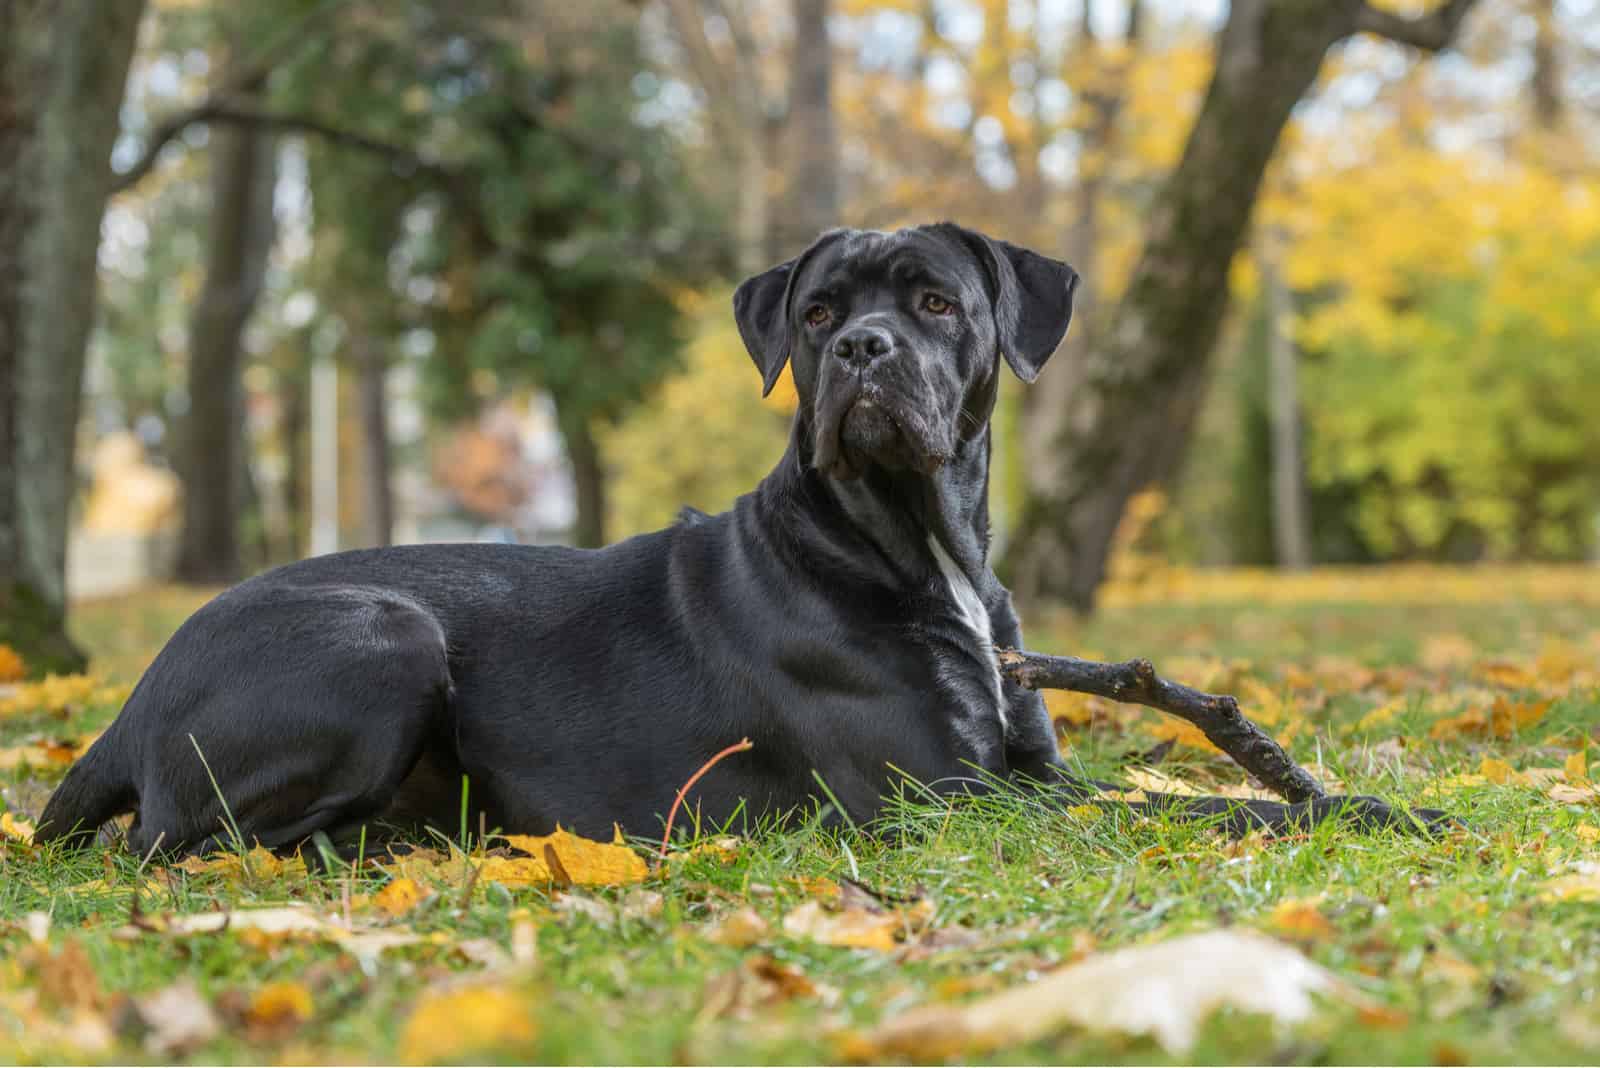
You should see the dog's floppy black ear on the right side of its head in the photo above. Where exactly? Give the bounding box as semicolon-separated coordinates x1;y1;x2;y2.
952;227;1078;382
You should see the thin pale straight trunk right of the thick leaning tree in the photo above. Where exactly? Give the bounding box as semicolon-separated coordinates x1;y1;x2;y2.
1259;233;1310;571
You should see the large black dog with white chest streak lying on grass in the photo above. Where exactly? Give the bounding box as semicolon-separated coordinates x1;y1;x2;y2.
38;224;1427;852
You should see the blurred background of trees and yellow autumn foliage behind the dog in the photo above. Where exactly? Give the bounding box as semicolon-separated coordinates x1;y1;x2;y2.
0;0;1600;670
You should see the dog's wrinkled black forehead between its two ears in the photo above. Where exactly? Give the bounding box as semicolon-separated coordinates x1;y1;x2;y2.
789;229;994;306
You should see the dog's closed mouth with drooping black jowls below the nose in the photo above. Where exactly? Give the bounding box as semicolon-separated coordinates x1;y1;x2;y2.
813;385;949;480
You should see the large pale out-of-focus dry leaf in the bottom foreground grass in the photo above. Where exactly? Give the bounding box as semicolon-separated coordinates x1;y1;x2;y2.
850;931;1354;1060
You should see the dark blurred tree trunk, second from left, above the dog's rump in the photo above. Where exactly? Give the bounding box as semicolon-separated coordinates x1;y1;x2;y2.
178;85;277;585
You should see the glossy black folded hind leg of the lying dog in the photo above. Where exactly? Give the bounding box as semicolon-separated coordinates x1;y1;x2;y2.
123;587;451;851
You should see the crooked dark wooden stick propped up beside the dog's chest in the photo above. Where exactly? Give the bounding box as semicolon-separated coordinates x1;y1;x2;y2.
997;649;1325;801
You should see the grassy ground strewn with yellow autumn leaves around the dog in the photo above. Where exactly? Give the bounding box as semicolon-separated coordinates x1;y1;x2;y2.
0;569;1600;1063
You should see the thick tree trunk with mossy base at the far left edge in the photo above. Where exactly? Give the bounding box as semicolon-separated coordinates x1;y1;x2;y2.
0;0;144;671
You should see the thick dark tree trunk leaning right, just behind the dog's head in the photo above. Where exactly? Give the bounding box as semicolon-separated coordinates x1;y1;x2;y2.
1006;0;1472;612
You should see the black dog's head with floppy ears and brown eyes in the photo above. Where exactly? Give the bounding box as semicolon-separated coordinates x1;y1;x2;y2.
733;222;1078;478
